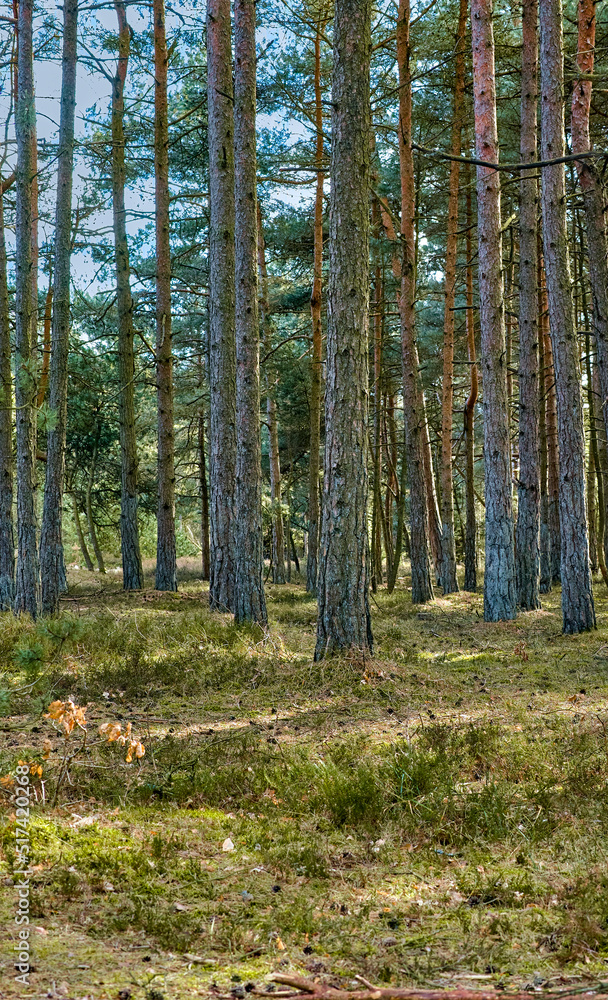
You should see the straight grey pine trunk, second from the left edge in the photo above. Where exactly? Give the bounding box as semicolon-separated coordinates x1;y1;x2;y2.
15;0;40;618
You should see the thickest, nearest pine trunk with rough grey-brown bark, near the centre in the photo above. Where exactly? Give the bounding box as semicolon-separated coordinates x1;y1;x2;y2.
315;0;372;660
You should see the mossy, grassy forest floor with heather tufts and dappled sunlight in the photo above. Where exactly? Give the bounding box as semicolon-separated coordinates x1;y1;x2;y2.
0;563;608;1000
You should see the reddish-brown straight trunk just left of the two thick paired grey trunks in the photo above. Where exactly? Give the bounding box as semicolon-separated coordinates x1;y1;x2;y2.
154;0;177;590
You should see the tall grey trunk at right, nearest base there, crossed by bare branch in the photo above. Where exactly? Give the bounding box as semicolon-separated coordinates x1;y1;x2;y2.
539;0;595;633
